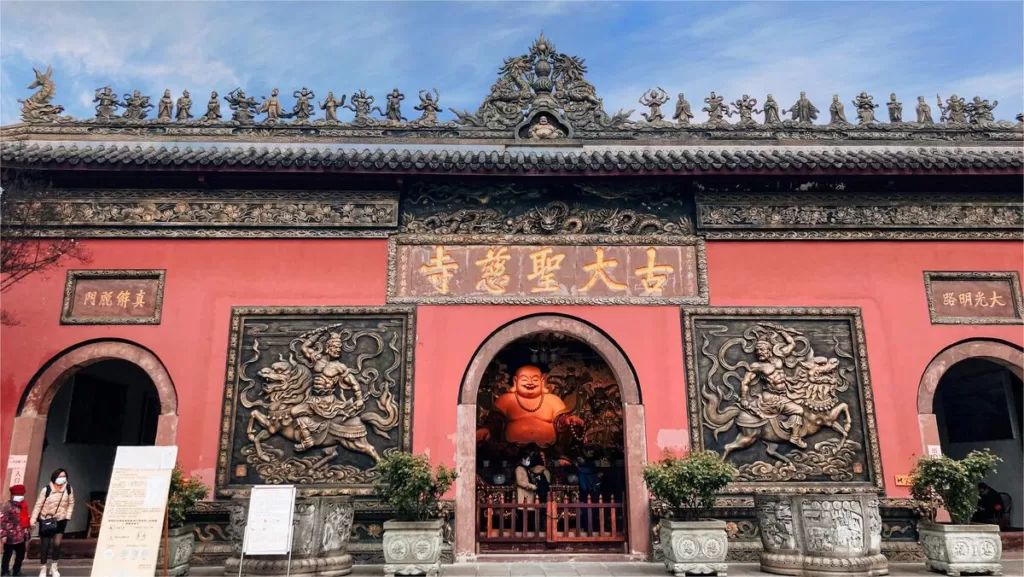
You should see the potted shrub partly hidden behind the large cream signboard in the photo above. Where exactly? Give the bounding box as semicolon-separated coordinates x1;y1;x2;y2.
156;463;209;575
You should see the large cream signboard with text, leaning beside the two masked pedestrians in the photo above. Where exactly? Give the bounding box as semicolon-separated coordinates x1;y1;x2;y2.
91;447;178;577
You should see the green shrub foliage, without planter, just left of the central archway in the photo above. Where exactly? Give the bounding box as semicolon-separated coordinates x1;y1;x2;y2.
374;453;458;521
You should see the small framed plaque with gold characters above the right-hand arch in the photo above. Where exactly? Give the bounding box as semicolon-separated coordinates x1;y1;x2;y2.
925;271;1024;325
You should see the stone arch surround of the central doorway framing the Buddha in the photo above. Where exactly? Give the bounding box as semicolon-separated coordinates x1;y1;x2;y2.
455;315;650;561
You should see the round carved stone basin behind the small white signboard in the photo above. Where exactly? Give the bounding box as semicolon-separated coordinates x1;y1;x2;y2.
224;497;355;577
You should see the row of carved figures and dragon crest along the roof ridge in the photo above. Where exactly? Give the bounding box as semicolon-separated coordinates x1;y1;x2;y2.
3;33;1024;141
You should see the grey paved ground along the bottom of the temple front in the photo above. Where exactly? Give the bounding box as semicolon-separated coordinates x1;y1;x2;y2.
36;555;1024;577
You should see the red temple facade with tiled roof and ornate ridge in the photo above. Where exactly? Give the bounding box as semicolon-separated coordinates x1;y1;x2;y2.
0;36;1024;564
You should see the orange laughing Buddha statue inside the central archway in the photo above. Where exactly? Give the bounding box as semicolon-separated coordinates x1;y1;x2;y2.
477;365;583;447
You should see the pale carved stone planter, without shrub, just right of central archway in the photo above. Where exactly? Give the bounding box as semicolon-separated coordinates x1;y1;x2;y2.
659;519;729;577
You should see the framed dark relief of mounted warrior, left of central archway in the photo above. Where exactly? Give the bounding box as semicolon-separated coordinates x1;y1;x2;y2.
217;307;414;494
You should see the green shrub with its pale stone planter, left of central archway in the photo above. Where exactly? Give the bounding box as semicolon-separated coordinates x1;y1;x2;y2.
376;453;456;577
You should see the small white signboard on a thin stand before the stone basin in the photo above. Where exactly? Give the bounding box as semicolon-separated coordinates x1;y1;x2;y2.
243;485;295;554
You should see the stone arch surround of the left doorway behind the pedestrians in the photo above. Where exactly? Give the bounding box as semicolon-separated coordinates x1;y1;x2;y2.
4;341;178;508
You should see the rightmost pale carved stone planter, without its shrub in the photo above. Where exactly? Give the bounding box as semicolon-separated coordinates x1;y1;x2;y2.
918;522;1002;575
